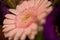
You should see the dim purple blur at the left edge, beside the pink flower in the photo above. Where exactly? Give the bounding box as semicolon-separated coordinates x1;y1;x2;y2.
0;0;9;24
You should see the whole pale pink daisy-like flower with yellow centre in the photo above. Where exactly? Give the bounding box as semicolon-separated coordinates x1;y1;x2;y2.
3;0;52;40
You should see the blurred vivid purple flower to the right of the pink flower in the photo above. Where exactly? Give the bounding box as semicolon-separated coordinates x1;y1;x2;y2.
44;7;60;40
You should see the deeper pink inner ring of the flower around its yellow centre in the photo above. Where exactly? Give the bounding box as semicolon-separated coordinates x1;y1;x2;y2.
16;12;36;28
